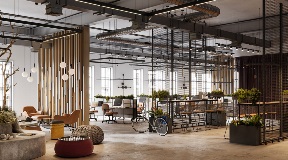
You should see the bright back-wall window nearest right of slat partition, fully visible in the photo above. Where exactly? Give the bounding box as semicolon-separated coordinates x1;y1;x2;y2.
101;67;113;96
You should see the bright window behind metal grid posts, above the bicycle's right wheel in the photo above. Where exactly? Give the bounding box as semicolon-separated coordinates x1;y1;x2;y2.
148;70;165;95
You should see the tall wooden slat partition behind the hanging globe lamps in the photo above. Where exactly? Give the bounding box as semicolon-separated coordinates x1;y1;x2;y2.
38;26;90;125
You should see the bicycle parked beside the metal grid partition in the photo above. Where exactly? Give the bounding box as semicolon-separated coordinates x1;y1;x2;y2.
131;116;168;136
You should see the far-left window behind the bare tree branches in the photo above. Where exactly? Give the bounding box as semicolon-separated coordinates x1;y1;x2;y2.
0;61;13;109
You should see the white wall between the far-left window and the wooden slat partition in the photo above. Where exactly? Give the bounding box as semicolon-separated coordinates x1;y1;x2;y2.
0;45;38;115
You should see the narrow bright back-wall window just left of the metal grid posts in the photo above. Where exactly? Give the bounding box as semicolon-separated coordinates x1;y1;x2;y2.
133;69;143;97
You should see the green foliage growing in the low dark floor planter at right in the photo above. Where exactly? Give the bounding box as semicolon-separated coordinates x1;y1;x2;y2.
231;115;263;127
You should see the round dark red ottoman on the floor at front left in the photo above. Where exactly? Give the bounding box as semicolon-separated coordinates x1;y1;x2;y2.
54;137;94;158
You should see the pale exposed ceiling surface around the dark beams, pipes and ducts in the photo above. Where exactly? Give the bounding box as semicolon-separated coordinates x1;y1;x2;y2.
0;0;276;70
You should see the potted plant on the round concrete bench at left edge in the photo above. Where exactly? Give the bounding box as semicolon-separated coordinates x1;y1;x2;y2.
0;107;16;134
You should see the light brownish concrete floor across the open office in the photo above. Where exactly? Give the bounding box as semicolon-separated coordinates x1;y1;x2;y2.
37;121;288;160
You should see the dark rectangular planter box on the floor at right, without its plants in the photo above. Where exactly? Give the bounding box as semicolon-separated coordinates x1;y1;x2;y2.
230;124;261;146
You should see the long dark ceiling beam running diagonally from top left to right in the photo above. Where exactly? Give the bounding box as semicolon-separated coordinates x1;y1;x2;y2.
60;0;271;48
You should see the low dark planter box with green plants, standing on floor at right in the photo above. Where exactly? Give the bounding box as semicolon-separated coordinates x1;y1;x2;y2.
229;115;263;146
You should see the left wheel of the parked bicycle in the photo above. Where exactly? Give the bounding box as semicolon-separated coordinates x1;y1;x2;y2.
131;117;149;133
